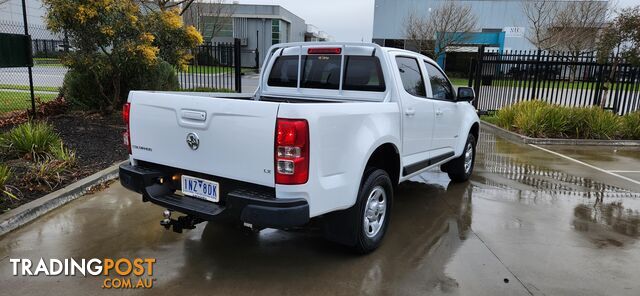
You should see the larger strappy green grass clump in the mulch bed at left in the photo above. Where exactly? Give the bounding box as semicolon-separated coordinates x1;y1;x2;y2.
0;122;62;160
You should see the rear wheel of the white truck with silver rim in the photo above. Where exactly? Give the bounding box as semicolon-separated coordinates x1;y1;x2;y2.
324;168;393;254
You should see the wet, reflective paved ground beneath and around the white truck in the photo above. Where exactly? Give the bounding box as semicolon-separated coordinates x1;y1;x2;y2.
0;133;640;295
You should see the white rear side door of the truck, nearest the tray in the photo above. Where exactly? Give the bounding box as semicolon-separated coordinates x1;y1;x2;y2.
395;55;434;168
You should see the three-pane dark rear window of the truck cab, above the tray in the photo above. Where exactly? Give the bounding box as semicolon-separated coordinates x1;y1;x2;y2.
267;55;385;92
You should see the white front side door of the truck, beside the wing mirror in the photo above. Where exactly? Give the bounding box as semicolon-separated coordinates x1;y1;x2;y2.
424;61;462;157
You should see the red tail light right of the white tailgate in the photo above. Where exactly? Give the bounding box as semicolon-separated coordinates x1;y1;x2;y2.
274;118;309;185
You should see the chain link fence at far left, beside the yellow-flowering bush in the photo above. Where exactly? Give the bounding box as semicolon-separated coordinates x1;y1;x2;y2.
0;21;65;117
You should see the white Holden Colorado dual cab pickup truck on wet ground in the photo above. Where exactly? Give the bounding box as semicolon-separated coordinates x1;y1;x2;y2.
120;43;479;253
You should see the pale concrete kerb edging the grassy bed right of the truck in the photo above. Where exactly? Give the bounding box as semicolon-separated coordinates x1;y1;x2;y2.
481;121;640;146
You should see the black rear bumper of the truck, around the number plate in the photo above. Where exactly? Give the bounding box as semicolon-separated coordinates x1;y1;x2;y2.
119;164;309;228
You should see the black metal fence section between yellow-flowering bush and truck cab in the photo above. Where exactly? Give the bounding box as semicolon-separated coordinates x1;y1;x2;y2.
178;39;242;92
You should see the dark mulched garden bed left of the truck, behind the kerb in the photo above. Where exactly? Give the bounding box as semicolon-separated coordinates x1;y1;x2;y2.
0;113;127;213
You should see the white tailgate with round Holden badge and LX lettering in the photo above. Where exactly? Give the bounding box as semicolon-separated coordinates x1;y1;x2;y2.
129;92;279;186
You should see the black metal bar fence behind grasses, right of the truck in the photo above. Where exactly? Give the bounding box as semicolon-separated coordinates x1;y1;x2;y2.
469;47;640;115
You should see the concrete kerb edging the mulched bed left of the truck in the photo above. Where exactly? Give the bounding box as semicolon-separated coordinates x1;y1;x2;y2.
0;163;126;236
